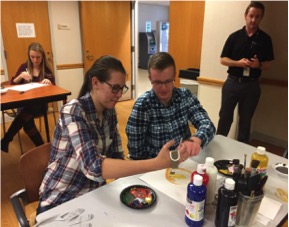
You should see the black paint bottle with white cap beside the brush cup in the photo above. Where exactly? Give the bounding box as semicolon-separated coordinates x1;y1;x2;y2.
215;178;238;227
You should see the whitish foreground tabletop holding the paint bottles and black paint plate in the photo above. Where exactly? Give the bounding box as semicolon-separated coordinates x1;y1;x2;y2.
37;135;288;227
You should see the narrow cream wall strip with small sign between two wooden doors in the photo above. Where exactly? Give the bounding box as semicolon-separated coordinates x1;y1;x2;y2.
48;1;84;100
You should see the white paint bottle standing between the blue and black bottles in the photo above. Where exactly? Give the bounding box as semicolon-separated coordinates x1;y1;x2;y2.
205;157;218;204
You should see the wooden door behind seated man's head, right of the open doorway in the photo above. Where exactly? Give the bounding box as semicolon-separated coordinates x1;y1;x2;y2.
169;1;205;87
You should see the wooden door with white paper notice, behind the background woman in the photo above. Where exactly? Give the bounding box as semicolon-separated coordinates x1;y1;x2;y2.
1;1;53;79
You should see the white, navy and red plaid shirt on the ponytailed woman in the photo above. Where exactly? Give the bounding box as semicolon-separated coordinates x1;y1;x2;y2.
40;93;123;207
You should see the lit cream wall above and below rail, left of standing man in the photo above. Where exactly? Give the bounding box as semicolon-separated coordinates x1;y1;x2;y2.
198;1;248;138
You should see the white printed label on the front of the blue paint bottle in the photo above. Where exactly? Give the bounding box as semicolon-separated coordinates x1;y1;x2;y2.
186;198;205;221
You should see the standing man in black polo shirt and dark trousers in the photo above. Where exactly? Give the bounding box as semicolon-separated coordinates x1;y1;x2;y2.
217;2;274;143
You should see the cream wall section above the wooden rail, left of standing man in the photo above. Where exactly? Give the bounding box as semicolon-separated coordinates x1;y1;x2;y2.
200;1;249;80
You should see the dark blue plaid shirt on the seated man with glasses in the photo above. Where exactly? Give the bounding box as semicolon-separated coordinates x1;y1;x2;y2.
126;88;216;159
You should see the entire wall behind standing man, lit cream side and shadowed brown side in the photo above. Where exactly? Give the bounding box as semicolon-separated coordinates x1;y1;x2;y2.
198;1;288;147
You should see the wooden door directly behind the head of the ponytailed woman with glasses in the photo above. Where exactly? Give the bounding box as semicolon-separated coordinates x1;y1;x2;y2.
79;1;132;100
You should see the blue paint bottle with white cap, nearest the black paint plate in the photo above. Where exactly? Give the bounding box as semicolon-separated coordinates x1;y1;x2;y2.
185;174;207;227
